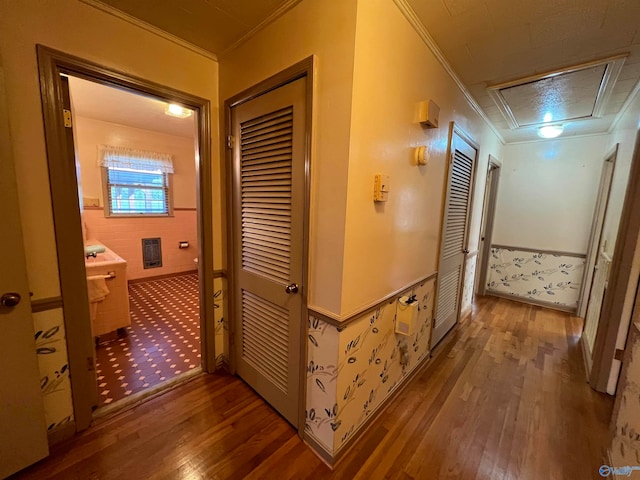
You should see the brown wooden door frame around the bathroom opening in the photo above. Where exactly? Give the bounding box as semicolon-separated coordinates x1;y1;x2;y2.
36;45;215;431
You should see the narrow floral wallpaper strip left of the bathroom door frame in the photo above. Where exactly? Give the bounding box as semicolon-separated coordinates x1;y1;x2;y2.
33;308;73;431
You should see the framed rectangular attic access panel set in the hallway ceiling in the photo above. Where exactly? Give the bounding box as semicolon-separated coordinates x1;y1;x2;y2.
487;55;625;129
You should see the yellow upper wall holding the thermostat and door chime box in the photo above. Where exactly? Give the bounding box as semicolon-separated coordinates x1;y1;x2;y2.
339;0;500;316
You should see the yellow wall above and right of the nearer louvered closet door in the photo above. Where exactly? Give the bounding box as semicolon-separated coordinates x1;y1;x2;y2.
220;0;356;312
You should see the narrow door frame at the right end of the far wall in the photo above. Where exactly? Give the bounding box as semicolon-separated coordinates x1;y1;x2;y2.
576;143;620;318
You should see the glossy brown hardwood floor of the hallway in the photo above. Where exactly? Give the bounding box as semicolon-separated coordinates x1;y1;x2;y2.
16;297;613;480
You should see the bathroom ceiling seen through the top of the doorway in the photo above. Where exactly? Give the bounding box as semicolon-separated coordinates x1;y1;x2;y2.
69;77;196;138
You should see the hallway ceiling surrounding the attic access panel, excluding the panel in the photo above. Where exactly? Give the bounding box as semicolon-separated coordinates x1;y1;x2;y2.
406;0;640;142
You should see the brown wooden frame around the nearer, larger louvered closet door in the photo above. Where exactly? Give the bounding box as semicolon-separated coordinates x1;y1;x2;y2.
224;55;315;437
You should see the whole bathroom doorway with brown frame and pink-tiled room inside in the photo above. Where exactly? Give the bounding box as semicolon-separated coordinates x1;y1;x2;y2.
38;46;215;431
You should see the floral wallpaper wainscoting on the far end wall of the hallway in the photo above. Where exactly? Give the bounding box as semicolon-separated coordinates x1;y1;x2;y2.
487;247;585;311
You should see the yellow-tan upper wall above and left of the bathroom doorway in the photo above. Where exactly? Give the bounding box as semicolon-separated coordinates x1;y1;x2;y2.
0;0;222;300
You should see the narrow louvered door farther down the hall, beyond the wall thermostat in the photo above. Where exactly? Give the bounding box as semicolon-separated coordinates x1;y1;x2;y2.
431;129;477;347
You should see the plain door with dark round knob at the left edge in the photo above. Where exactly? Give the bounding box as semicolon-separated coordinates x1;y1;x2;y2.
0;67;49;478
